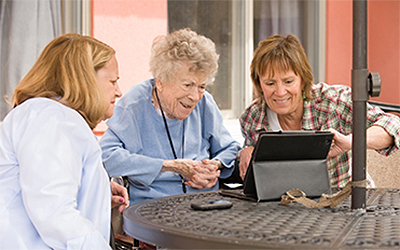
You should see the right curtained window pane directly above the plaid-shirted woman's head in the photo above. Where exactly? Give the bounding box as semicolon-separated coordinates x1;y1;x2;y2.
253;0;326;81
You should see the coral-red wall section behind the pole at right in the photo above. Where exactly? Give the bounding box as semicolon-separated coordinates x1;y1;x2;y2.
326;0;400;104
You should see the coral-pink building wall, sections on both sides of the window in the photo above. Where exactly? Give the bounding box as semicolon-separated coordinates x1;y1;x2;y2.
92;0;400;109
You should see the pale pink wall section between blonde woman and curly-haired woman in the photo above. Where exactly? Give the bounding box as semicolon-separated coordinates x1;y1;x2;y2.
91;0;167;133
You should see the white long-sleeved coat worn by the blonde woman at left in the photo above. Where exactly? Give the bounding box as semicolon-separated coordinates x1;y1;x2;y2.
0;98;111;249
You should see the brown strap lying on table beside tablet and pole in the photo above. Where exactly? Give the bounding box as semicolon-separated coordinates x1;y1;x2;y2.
281;180;367;208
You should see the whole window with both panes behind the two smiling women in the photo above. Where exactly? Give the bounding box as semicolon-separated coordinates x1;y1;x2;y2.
168;0;325;119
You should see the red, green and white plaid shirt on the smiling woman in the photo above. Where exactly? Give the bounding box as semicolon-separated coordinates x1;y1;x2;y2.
239;83;400;188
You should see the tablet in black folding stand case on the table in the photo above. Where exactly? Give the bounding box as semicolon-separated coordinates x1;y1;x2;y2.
243;131;333;201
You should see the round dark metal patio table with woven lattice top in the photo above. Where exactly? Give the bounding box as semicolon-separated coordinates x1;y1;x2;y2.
124;189;400;249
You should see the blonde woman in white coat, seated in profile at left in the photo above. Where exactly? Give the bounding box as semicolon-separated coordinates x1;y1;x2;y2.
0;34;128;249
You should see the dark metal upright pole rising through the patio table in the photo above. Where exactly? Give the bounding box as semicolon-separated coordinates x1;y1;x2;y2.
351;0;368;209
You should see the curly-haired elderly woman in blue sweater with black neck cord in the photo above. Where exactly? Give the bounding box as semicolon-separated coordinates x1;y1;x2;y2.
100;29;240;203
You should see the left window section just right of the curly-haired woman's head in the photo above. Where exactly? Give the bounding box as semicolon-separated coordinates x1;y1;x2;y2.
168;0;248;119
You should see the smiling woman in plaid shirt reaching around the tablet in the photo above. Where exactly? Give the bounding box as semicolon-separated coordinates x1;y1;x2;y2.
239;35;400;188
